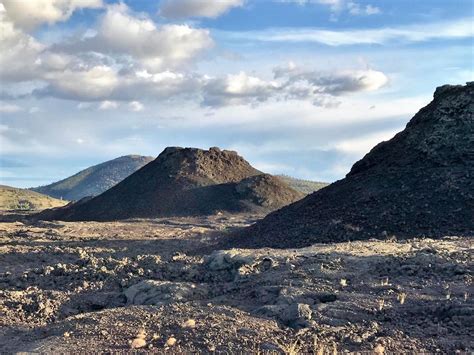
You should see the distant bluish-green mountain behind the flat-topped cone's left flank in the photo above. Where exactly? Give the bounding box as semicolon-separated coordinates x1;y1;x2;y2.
31;155;154;201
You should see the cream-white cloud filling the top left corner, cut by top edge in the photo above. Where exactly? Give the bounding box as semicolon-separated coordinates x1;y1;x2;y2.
0;0;103;30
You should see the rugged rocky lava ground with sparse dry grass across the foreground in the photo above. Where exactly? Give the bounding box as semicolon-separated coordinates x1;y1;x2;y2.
0;211;474;354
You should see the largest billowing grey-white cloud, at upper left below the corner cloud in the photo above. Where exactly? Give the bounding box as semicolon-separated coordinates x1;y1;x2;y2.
0;3;213;103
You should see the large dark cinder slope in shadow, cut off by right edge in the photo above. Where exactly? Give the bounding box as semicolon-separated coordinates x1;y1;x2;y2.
231;82;474;248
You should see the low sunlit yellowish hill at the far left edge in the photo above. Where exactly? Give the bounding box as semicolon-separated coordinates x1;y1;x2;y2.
0;185;67;210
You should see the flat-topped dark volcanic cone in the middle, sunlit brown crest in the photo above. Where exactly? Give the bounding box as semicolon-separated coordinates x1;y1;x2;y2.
38;147;303;221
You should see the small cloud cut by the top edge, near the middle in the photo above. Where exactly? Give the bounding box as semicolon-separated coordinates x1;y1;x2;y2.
159;0;244;19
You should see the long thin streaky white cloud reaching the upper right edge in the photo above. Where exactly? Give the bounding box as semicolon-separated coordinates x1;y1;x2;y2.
236;18;474;46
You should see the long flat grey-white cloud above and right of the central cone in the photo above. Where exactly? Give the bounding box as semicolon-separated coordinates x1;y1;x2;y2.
202;62;388;107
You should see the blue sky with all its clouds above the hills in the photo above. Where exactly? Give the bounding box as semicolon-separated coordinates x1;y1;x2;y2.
0;0;474;187
